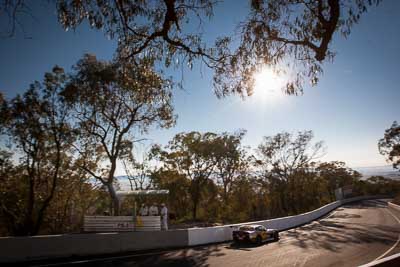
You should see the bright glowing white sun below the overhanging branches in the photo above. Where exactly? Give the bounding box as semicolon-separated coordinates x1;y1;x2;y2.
252;67;284;101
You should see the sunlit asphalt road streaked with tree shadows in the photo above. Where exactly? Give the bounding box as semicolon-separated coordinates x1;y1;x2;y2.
33;200;400;267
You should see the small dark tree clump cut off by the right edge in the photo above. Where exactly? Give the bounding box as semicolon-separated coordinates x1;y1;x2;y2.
378;121;400;172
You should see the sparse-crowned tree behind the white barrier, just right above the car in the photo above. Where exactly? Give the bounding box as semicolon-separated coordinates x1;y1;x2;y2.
255;131;324;215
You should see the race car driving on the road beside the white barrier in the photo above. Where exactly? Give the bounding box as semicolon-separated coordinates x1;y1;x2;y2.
232;224;279;244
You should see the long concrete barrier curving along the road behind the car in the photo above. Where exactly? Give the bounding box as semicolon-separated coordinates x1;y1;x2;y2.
0;196;388;262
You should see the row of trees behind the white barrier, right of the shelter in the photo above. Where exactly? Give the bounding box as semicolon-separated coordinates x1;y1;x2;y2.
152;131;368;222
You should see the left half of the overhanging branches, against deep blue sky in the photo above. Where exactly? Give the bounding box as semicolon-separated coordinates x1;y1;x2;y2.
57;0;225;66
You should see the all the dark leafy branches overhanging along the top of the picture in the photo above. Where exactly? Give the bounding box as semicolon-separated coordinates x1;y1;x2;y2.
57;0;380;96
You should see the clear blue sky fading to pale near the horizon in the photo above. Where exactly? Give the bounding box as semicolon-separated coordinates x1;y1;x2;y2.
0;0;400;175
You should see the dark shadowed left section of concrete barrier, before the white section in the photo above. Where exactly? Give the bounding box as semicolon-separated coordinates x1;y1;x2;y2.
0;230;188;262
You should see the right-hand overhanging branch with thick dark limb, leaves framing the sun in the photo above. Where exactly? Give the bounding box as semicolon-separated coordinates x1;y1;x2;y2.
214;0;380;94
